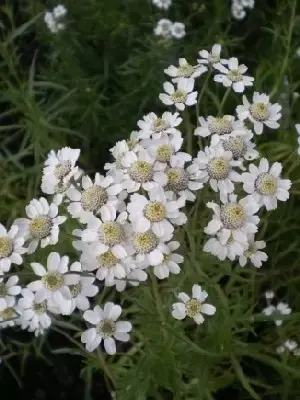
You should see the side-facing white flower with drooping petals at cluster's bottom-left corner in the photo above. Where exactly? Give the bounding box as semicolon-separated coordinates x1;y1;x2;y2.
16;288;52;336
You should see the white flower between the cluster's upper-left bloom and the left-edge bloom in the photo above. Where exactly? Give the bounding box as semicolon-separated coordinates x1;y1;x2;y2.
14;197;67;254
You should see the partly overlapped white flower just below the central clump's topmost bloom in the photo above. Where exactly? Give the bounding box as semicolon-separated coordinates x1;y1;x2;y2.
143;131;192;170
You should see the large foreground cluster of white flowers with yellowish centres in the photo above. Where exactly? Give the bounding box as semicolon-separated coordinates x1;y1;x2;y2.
0;45;291;354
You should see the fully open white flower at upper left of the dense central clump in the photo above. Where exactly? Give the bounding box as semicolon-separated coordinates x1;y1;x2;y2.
122;149;166;193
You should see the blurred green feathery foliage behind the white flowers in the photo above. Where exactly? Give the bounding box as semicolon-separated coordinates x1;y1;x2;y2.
0;0;300;400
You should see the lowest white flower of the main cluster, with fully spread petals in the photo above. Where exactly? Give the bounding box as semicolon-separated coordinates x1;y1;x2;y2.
81;302;132;355
